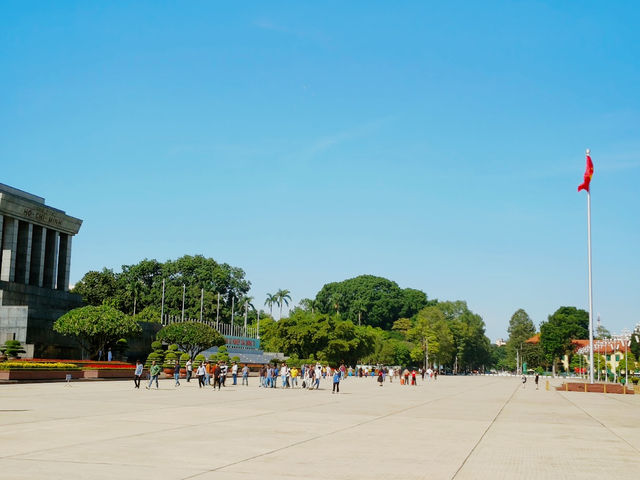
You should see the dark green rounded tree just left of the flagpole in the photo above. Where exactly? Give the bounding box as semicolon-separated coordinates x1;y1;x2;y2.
540;307;589;375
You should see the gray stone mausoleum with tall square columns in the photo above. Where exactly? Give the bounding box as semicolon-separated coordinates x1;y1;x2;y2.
0;183;82;358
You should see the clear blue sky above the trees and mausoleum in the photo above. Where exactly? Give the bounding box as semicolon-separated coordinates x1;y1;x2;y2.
0;1;640;339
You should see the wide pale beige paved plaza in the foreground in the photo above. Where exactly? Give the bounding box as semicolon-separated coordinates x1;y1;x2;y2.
0;377;640;480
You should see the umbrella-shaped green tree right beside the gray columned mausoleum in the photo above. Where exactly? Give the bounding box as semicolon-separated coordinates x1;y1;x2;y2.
53;305;142;358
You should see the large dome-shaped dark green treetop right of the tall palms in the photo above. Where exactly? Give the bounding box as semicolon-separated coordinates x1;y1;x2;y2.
316;275;429;330
